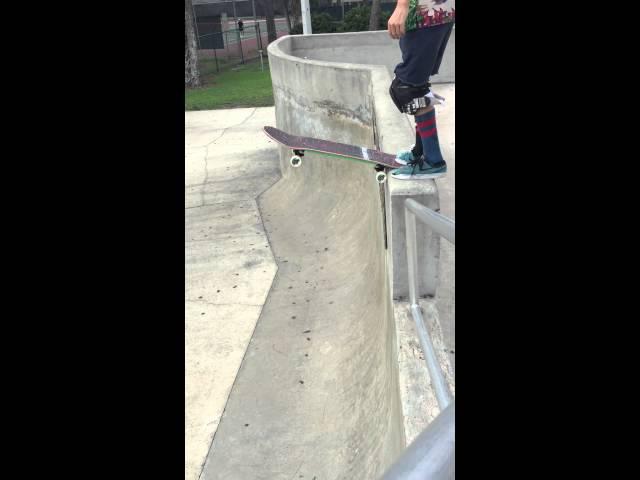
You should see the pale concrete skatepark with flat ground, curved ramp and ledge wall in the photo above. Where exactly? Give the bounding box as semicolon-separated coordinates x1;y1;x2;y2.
185;27;455;480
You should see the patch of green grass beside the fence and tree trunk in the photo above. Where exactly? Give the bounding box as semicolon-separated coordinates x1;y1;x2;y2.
184;58;274;110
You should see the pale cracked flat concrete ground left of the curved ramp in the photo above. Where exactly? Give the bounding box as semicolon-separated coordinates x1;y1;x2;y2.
185;108;280;480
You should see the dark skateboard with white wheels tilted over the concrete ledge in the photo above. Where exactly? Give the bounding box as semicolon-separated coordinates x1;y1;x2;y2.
264;127;404;183
